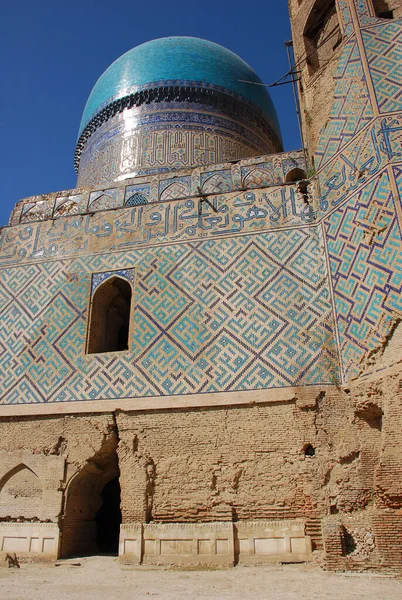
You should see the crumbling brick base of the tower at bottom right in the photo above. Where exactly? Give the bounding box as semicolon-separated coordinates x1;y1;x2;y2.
323;370;402;572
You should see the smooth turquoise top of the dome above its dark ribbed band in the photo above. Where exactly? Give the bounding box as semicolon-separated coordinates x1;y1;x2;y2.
79;37;281;139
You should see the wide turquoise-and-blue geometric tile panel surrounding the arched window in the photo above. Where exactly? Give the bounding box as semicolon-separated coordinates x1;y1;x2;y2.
0;228;339;403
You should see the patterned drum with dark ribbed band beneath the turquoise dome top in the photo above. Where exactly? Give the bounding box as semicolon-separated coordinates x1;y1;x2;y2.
75;85;281;187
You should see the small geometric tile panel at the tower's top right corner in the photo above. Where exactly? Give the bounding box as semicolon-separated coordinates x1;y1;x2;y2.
362;21;402;112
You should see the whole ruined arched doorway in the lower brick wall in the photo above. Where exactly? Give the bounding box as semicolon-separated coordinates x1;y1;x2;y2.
60;439;121;558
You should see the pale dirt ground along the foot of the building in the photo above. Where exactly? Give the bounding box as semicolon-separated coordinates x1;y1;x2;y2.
0;556;402;600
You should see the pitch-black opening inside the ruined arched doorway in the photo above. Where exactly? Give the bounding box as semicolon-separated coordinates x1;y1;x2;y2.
95;477;121;555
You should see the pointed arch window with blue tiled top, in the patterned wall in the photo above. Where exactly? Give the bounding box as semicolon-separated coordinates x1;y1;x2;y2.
86;271;132;354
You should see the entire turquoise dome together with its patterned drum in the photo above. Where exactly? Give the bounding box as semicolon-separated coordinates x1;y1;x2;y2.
75;37;282;186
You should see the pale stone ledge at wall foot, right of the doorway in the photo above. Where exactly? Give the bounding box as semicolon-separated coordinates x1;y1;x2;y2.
119;520;312;566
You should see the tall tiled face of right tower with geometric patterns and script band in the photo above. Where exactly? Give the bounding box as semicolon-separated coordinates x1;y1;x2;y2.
317;10;402;380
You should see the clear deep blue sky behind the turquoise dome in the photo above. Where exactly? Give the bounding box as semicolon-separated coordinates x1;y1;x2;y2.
0;0;301;225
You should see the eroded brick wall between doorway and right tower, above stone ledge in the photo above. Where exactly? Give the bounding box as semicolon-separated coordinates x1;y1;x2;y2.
117;402;324;523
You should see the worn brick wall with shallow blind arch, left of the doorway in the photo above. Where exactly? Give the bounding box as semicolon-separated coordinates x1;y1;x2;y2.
0;415;115;522
